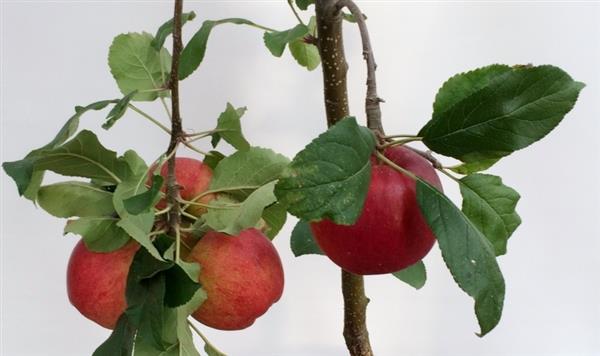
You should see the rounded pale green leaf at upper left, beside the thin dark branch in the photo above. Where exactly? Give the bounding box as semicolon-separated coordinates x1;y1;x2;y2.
108;32;171;101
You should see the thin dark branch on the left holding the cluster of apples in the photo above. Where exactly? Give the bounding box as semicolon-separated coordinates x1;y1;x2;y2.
166;0;185;257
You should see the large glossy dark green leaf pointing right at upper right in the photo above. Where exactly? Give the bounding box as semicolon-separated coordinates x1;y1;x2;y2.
419;65;584;162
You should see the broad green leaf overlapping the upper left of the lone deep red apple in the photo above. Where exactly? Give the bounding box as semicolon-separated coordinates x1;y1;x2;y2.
275;117;375;225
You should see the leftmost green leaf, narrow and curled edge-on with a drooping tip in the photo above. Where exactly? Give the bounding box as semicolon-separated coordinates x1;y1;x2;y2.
2;100;116;200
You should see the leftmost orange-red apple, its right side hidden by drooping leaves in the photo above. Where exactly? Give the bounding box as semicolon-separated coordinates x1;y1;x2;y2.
67;240;139;329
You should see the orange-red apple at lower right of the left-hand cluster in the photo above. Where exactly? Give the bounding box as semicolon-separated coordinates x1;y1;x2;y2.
187;228;284;330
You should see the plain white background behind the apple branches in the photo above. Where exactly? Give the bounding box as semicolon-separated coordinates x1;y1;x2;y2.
0;0;600;356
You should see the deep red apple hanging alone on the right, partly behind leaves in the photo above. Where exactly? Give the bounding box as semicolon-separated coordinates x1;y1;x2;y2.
311;146;442;275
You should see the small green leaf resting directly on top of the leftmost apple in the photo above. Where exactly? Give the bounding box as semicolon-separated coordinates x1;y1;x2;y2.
64;216;130;252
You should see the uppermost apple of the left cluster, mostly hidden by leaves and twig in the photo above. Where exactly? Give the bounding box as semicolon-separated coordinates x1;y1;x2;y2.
148;157;215;216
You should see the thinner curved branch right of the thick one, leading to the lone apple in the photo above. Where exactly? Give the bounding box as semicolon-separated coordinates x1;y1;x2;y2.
337;0;384;135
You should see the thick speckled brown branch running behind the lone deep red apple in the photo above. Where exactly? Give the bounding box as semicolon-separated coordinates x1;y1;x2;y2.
315;0;373;356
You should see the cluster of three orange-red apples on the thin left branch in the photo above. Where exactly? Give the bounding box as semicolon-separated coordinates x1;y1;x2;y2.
67;158;284;330
